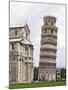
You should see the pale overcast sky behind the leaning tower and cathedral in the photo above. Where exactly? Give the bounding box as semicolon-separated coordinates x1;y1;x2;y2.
10;2;65;67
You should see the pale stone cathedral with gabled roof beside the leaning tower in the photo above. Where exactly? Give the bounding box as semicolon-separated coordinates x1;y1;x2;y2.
9;24;33;83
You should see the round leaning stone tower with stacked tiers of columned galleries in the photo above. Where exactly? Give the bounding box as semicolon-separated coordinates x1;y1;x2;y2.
39;16;57;81
